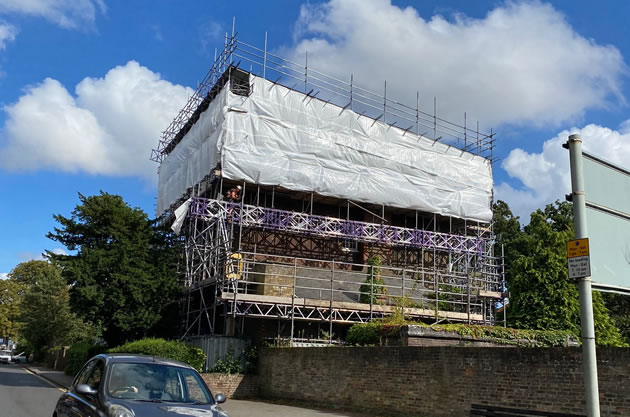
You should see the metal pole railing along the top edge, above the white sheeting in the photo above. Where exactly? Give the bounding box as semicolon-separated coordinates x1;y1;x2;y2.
151;34;495;162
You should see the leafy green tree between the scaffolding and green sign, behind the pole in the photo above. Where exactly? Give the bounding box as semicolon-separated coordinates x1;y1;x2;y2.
495;201;623;346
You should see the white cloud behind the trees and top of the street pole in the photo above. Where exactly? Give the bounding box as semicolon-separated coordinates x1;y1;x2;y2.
495;120;630;219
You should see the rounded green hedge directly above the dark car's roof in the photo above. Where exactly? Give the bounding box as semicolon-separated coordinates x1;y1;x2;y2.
108;339;206;371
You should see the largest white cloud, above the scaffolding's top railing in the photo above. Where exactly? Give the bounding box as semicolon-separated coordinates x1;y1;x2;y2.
281;0;627;130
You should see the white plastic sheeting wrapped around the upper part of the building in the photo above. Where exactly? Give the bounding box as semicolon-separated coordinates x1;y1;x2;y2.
157;78;493;222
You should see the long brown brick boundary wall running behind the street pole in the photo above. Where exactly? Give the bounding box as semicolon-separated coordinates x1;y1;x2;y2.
259;347;630;417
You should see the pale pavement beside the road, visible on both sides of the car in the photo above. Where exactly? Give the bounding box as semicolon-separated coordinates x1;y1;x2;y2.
21;364;367;417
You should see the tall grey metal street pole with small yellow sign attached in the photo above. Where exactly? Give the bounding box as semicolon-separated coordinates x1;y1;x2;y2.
568;135;599;417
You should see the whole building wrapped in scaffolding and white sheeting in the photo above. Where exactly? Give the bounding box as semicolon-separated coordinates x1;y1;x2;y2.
152;35;503;340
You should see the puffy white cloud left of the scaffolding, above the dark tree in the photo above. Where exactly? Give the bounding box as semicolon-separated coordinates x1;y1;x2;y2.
0;61;193;182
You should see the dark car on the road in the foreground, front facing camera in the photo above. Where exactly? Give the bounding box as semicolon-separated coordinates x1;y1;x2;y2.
53;354;227;417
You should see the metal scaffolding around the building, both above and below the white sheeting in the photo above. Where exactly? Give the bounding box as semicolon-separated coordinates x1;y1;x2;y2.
156;30;504;340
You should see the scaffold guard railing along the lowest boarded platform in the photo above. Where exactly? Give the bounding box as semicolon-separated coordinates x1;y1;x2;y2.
222;252;501;319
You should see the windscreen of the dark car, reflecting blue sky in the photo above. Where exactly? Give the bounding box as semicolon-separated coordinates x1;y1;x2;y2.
107;362;213;404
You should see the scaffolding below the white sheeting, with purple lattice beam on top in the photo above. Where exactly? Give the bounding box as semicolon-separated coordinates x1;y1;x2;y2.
180;192;503;338
